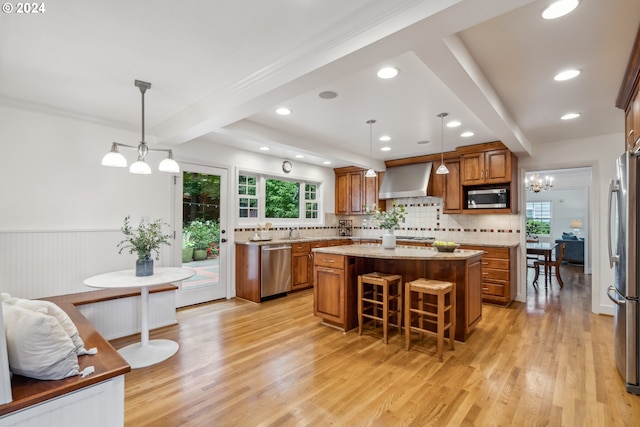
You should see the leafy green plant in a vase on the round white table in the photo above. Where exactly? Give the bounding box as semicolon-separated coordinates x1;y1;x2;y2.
118;215;171;276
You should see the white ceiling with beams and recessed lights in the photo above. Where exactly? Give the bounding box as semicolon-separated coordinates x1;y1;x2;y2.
0;0;640;169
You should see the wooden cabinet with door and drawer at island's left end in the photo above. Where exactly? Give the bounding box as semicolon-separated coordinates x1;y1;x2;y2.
313;253;357;331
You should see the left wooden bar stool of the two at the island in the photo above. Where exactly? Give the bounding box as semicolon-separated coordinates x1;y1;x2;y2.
358;272;402;344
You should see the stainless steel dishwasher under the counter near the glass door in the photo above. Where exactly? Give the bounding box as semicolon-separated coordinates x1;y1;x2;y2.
260;243;291;298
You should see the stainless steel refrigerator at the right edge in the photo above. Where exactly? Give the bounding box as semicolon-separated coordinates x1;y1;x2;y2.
607;152;640;394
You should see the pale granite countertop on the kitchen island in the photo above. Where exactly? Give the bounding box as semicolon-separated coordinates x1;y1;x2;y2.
312;245;483;261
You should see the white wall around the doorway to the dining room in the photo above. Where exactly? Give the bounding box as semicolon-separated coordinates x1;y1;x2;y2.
518;132;624;314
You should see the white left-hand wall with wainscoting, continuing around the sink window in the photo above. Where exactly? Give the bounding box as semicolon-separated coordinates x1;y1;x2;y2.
0;106;334;298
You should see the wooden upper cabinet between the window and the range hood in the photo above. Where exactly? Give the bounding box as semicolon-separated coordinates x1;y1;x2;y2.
334;167;386;215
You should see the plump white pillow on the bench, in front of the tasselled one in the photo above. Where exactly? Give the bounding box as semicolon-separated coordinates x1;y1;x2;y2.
2;302;80;380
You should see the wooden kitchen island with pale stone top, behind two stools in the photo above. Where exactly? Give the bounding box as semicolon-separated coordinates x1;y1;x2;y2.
313;245;483;341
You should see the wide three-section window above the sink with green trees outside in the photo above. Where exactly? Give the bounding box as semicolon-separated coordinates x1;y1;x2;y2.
238;173;321;224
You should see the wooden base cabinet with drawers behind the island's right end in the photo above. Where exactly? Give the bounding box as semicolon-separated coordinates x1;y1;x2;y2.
461;245;517;305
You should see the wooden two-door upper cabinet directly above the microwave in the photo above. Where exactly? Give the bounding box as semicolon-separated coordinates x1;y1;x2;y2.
461;148;513;185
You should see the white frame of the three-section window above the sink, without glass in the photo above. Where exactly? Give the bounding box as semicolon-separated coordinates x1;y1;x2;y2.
235;170;324;227
